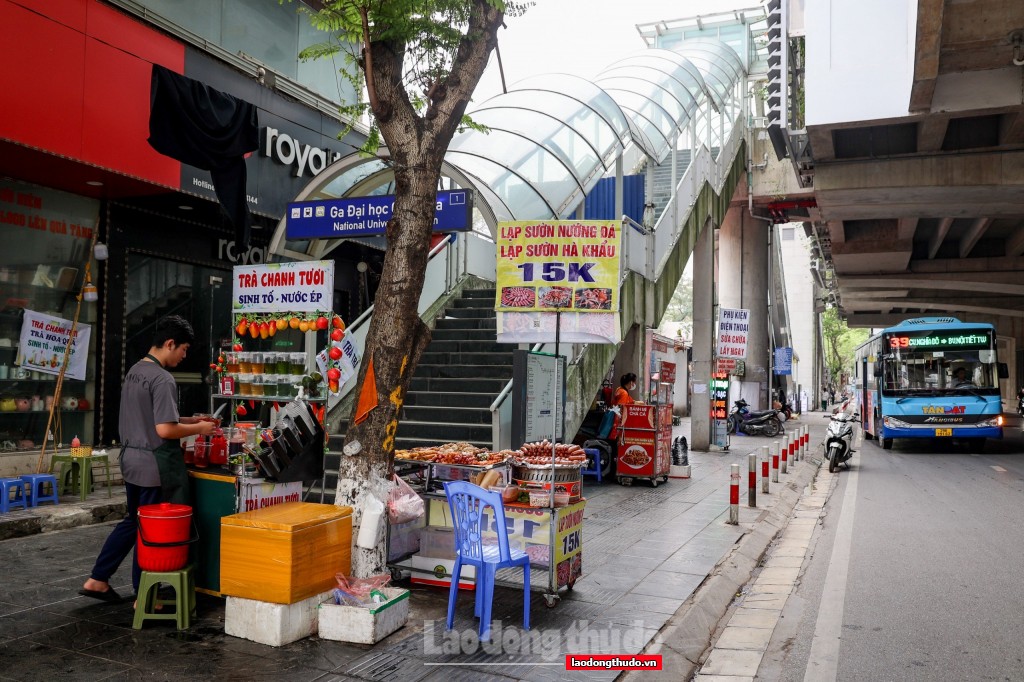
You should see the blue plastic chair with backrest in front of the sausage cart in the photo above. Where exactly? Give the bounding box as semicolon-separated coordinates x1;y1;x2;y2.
444;481;529;642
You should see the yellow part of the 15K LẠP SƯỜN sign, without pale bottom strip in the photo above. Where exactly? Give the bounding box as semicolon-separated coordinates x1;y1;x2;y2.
495;220;622;312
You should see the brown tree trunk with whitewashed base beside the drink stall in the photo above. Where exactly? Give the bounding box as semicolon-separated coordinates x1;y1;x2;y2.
336;0;503;578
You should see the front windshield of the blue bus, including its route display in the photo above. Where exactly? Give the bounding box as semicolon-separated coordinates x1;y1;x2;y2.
882;330;999;395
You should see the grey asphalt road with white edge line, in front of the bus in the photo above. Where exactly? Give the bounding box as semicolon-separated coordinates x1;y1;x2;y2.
759;422;1024;682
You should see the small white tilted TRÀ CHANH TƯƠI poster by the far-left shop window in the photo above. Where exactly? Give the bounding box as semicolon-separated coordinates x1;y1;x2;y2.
18;310;92;379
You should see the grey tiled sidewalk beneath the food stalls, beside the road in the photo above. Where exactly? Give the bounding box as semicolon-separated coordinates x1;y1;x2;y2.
0;413;826;682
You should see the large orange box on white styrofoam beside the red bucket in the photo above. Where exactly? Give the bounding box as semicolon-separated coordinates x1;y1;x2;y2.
220;502;352;604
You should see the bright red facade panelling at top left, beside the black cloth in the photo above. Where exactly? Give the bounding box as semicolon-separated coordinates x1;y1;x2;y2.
0;0;184;187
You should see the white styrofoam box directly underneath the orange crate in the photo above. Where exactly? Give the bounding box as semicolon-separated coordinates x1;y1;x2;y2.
224;592;332;646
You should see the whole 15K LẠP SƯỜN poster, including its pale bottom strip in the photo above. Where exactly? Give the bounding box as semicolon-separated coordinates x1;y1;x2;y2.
495;220;622;343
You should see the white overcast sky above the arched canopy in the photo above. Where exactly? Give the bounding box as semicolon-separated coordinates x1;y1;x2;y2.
471;0;761;103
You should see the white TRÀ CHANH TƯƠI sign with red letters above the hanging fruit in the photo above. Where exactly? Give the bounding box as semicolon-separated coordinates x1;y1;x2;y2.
231;260;334;313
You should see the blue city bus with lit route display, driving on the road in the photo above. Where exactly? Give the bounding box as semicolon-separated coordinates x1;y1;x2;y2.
855;317;1009;452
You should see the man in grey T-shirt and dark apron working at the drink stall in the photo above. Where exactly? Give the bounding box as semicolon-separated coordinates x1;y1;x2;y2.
79;315;216;601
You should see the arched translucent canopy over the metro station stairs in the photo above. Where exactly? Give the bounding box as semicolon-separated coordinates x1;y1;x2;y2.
280;38;744;253
